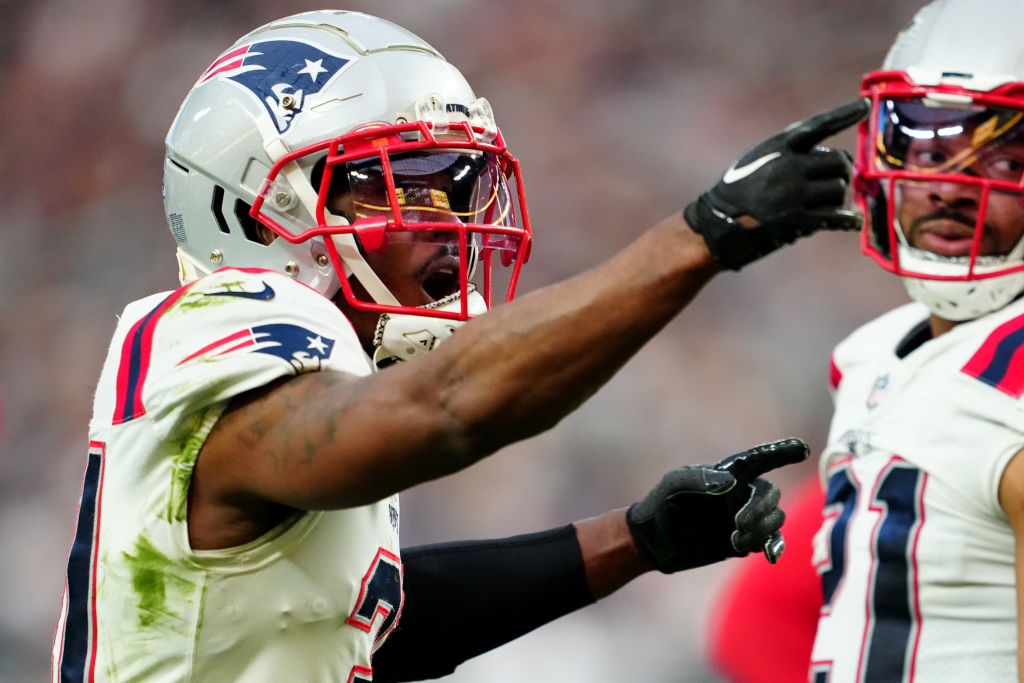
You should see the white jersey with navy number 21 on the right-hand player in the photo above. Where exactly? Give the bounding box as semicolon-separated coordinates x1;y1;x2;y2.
809;301;1024;683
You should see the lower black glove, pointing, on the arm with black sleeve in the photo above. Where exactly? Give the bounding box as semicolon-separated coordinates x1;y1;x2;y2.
626;438;808;573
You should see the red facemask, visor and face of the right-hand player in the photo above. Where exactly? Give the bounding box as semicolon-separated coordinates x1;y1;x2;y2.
854;72;1024;281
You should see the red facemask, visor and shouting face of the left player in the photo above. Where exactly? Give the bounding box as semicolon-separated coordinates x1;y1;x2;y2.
252;121;530;319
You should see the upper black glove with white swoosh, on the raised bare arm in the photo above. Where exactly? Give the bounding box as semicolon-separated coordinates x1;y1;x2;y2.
683;99;870;270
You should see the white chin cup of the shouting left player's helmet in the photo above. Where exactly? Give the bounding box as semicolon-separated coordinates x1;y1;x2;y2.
374;285;487;369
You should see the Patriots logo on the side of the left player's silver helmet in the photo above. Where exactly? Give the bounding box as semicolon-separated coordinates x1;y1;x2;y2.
199;40;350;133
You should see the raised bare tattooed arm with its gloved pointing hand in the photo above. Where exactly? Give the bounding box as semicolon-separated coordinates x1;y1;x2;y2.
189;102;864;528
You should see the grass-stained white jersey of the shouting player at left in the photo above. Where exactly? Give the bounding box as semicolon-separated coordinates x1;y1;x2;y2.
53;268;402;683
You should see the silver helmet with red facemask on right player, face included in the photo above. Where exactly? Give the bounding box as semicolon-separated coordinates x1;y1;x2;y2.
854;0;1024;321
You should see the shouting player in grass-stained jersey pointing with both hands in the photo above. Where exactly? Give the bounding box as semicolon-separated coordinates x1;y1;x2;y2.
53;11;866;683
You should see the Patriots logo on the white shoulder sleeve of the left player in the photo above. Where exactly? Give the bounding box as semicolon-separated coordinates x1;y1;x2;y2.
178;323;334;374
